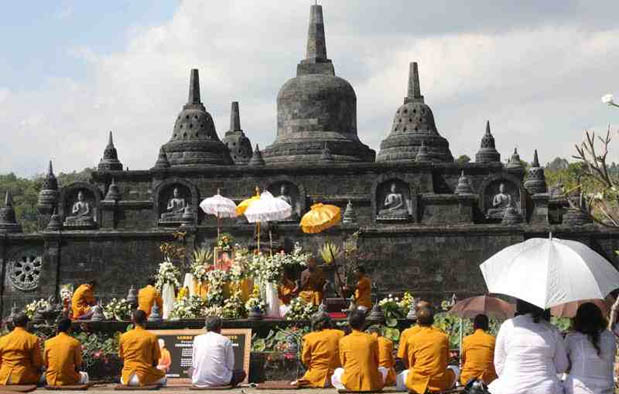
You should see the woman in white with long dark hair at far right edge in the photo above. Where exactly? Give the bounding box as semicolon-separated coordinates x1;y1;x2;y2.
564;302;617;394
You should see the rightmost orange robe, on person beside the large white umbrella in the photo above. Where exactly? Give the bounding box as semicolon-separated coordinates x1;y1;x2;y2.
460;329;497;385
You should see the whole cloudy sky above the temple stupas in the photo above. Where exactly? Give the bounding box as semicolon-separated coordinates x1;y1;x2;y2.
0;0;619;176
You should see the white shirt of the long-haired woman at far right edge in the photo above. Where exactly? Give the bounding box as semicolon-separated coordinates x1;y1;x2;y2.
564;330;617;394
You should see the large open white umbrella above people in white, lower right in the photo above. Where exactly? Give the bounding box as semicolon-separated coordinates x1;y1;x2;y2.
480;236;619;309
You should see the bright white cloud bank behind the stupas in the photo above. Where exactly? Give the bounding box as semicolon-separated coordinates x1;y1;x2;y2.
0;0;619;174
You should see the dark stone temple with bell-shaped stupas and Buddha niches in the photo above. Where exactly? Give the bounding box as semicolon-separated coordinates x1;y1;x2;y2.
0;5;619;313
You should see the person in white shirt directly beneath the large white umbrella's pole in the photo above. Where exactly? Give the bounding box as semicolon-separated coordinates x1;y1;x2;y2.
488;300;568;394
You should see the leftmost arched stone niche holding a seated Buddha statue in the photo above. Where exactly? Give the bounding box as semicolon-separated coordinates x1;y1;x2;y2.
59;182;102;230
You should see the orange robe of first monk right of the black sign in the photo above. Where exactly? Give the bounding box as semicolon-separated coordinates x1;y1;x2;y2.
299;329;344;388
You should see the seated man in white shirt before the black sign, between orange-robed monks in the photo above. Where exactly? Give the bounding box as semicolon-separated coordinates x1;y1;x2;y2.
191;317;247;387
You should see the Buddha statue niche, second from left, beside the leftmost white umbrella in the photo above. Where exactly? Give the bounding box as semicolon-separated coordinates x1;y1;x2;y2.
154;179;198;227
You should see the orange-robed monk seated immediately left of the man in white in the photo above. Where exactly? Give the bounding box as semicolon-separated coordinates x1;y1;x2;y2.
118;309;166;386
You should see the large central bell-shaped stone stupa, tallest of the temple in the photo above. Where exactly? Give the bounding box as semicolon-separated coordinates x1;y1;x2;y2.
263;5;376;164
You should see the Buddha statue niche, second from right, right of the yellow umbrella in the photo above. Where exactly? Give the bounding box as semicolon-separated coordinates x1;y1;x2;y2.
372;178;416;223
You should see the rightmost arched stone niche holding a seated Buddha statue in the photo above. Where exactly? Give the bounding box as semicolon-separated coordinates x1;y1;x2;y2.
480;176;526;223
